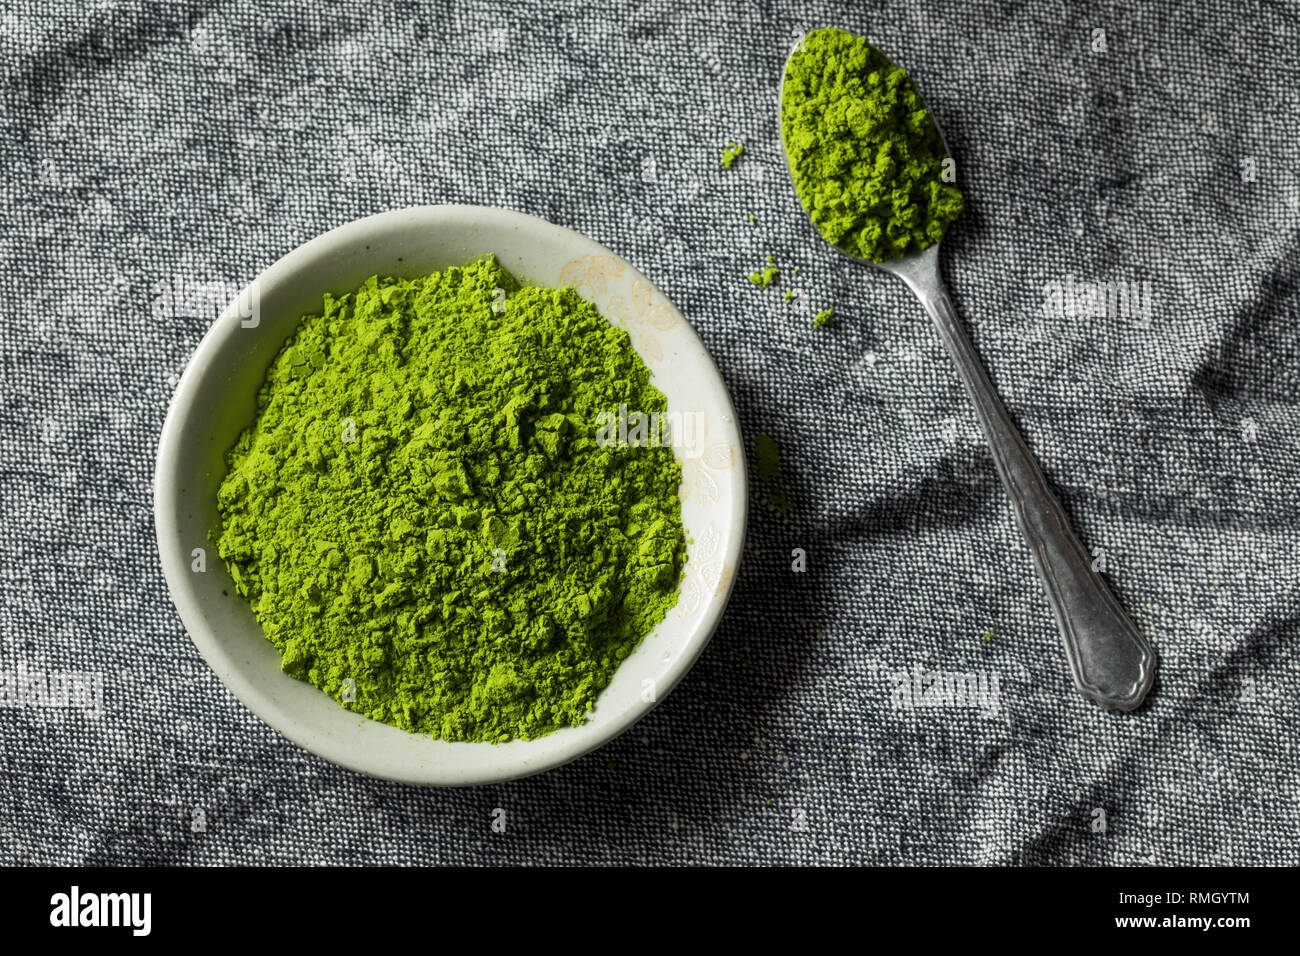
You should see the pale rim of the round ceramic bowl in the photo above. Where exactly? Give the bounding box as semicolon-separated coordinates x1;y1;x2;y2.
153;203;749;787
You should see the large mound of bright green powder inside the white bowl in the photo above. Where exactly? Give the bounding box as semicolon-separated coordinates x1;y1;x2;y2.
217;258;685;741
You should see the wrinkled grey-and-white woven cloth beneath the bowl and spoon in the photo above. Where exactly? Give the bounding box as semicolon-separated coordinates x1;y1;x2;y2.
0;0;1300;865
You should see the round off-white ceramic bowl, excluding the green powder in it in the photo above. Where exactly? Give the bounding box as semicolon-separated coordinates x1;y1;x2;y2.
153;206;746;786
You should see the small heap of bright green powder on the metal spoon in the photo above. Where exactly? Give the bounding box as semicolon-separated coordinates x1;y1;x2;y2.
781;29;962;263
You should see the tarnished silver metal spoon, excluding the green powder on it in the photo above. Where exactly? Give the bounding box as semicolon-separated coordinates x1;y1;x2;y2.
777;38;1156;710
